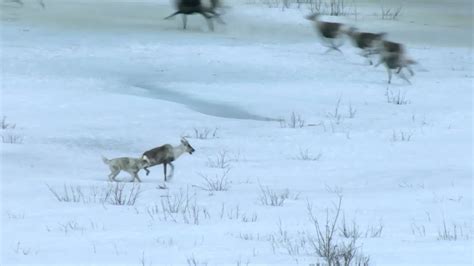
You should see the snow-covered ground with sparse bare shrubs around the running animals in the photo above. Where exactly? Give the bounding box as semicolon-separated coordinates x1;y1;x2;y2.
0;0;474;265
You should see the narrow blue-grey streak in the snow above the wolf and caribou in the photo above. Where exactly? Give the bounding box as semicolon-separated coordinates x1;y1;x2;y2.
132;83;279;121
